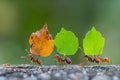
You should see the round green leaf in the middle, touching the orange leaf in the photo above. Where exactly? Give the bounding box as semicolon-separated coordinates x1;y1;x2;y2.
54;28;79;55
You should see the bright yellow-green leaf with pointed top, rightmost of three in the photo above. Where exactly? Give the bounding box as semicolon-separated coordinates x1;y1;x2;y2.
83;26;105;55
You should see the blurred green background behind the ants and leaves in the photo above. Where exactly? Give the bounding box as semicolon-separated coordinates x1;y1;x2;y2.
0;0;120;65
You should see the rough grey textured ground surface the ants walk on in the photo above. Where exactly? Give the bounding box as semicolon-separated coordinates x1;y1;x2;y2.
0;65;120;80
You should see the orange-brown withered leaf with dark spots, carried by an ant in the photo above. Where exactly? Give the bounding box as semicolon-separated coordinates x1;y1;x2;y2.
29;24;54;57
